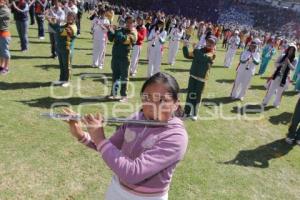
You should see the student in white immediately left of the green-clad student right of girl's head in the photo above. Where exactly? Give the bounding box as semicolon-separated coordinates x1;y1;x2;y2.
168;25;184;66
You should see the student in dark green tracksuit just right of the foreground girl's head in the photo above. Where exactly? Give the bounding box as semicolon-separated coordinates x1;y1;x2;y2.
182;35;217;121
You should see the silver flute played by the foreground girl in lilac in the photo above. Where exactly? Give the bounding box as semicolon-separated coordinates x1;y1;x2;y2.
41;113;169;126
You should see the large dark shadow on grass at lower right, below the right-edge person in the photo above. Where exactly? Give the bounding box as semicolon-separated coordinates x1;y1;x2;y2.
219;138;294;168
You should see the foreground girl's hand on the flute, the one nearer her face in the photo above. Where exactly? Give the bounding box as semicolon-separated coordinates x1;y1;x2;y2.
82;113;105;145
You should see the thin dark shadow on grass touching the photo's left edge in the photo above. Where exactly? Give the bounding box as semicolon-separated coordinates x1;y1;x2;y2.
0;82;51;90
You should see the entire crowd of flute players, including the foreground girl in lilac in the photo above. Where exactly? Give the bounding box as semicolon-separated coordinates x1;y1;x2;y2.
0;0;300;200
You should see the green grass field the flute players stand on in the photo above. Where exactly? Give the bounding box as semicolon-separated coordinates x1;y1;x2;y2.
0;16;300;200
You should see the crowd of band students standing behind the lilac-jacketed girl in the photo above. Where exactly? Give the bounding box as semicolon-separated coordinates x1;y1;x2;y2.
0;0;300;139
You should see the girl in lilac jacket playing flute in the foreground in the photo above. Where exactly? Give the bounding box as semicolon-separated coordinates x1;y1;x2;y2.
64;73;188;200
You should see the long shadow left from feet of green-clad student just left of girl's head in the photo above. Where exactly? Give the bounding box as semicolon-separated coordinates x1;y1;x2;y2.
17;96;118;109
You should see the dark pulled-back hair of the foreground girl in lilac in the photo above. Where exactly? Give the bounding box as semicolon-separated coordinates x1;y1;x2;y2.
140;72;183;117
